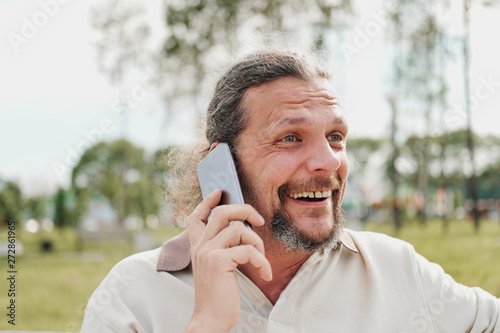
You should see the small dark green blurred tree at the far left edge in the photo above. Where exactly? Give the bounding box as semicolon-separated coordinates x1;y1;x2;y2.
0;181;25;230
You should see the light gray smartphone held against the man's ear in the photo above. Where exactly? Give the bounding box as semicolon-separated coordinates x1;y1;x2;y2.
196;143;252;229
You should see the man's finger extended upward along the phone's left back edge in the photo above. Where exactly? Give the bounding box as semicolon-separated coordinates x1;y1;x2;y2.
186;189;222;245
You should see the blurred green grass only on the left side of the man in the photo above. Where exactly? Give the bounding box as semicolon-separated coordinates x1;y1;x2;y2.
0;224;183;332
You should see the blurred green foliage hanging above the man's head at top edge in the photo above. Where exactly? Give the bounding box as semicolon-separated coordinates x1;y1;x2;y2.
164;0;353;62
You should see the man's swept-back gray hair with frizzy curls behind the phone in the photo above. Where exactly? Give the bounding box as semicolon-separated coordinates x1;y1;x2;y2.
166;51;330;223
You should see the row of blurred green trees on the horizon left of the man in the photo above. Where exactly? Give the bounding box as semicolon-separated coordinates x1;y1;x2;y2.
0;140;174;228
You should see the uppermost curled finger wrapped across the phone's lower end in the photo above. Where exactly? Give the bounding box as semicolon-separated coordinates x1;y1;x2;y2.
203;204;264;240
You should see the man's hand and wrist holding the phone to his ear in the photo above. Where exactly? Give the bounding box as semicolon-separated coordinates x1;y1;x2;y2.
185;190;272;332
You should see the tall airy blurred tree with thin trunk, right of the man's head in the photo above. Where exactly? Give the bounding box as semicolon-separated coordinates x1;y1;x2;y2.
389;0;450;223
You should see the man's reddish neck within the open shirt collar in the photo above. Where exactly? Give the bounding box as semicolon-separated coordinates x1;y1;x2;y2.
238;239;311;305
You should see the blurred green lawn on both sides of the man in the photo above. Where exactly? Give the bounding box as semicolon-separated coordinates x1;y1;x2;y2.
0;221;500;332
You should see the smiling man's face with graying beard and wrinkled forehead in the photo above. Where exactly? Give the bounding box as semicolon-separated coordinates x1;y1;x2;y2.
236;78;349;251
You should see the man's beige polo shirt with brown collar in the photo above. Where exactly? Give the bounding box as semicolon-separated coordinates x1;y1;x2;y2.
82;230;500;333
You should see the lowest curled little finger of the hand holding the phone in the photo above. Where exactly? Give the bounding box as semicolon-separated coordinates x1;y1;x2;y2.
225;245;273;281
